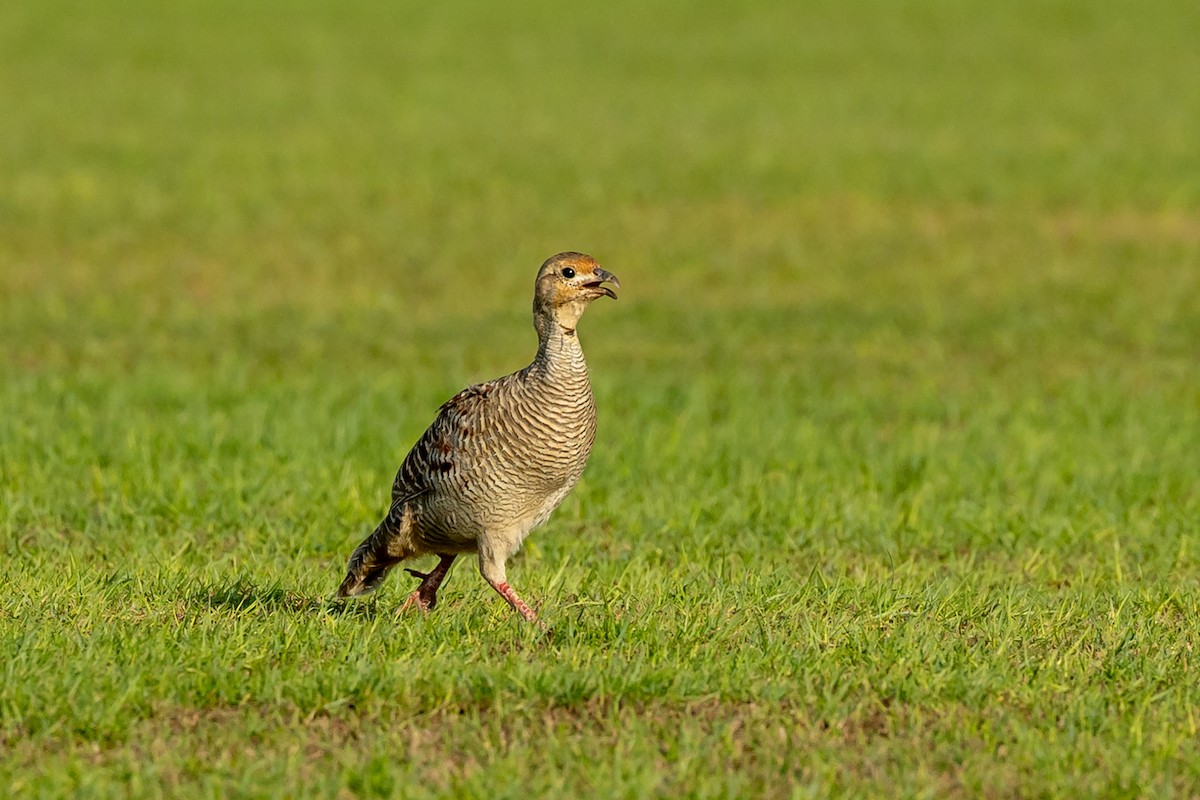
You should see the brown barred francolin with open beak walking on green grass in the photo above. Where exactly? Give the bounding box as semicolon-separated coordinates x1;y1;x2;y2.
337;251;620;630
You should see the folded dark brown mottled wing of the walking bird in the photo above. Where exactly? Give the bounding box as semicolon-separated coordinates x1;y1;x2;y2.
391;380;498;506
